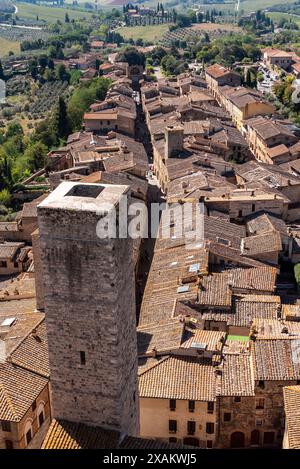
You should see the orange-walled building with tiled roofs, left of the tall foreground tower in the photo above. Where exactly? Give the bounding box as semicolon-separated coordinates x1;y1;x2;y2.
0;308;51;449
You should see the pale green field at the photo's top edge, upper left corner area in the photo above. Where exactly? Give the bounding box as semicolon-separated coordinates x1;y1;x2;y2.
17;3;92;23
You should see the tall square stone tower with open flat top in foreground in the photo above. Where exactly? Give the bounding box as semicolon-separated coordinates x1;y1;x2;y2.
38;182;139;435
